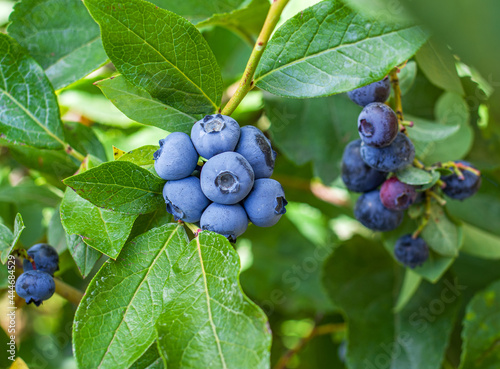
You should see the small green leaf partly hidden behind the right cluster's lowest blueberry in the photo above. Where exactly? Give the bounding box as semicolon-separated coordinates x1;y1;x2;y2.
382;219;455;283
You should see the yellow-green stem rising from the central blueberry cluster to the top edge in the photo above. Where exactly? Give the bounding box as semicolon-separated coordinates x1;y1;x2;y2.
222;0;289;115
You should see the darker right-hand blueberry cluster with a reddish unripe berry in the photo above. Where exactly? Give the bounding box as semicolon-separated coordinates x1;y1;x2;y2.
342;77;481;268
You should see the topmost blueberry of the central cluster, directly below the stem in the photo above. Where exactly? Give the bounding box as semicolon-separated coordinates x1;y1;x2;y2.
191;114;240;159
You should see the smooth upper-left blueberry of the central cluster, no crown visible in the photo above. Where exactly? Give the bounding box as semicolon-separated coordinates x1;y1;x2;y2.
154;132;198;180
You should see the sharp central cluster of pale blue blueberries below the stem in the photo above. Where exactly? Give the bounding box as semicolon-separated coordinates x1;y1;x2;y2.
154;114;287;242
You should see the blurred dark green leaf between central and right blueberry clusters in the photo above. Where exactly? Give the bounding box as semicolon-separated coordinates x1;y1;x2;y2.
265;95;361;184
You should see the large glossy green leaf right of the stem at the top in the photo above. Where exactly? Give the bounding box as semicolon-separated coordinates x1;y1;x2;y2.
255;0;427;98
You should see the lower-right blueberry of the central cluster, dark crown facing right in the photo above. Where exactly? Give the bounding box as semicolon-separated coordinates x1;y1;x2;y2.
243;178;288;227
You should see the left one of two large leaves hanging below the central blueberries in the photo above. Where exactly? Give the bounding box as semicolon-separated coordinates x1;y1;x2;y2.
73;224;188;369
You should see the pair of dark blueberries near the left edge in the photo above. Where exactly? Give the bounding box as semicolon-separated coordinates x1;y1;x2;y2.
16;243;59;306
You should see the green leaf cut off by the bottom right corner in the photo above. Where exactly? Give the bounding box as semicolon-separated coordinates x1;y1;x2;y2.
460;281;500;369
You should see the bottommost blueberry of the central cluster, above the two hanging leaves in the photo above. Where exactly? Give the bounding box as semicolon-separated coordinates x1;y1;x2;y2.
200;202;248;242
